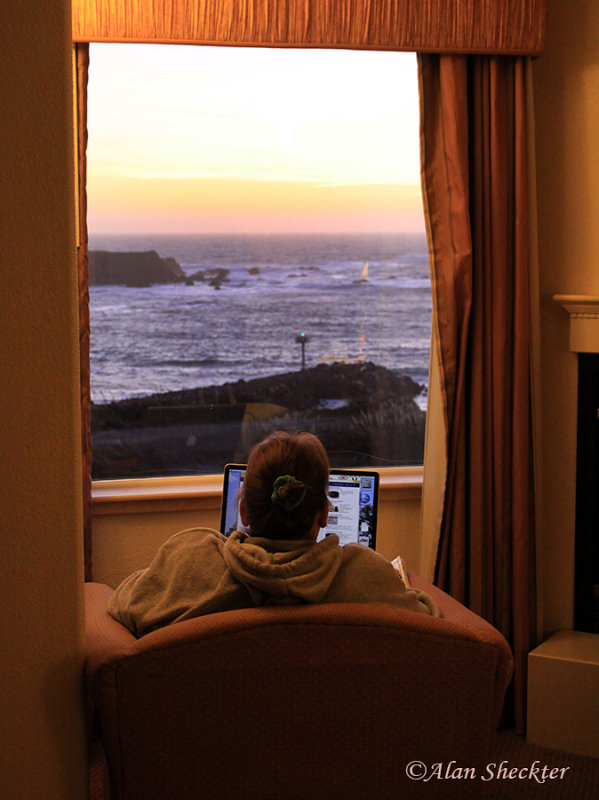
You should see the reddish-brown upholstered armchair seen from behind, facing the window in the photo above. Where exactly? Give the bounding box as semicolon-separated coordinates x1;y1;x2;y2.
86;576;512;800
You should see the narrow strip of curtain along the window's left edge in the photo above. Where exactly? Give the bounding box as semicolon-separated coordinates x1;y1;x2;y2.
75;44;92;580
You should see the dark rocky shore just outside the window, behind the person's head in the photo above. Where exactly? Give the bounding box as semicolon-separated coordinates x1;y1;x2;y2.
92;362;425;479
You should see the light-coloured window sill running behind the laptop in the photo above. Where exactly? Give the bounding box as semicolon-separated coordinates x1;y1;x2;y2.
92;467;423;516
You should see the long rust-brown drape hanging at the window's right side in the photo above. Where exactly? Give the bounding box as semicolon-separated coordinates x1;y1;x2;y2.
419;55;536;732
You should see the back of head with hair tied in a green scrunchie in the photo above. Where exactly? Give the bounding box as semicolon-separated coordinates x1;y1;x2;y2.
241;431;329;539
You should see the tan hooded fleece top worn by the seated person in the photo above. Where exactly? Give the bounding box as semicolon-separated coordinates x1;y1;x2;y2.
108;528;439;636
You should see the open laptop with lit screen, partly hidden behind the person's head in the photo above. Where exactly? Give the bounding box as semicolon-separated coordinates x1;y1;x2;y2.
220;464;379;550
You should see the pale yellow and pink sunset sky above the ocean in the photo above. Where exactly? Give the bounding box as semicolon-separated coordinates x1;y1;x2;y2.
88;44;424;235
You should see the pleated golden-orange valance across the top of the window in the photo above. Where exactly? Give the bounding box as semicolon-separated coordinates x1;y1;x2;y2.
72;0;547;55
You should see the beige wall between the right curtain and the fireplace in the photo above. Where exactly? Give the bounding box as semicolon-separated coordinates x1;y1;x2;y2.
534;0;599;634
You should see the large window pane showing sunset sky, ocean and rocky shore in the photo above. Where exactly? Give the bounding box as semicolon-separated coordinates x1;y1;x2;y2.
88;44;431;479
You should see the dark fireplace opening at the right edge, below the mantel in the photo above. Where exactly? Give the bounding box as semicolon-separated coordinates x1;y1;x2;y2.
574;353;599;633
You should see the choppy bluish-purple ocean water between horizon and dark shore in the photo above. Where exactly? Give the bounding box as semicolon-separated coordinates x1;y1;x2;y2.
90;234;432;402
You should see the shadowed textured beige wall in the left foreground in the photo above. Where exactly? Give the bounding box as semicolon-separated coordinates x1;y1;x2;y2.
0;0;86;800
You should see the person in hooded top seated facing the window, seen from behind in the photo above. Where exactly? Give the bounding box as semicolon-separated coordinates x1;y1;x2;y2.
108;432;438;636
